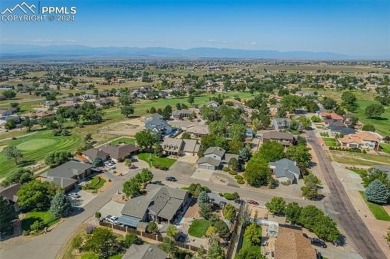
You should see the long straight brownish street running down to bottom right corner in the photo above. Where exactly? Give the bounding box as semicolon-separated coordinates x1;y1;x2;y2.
307;131;386;259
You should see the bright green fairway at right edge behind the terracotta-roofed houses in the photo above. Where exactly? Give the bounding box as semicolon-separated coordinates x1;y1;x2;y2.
318;90;390;136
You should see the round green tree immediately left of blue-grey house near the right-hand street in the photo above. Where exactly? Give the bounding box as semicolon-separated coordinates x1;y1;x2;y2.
244;157;271;187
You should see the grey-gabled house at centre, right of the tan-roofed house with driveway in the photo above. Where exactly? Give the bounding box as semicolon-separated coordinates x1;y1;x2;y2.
197;147;239;170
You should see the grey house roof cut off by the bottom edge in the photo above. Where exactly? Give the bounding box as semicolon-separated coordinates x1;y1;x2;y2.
122;244;169;259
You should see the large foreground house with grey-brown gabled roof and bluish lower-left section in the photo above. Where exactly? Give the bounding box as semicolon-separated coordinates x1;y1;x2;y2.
118;184;190;225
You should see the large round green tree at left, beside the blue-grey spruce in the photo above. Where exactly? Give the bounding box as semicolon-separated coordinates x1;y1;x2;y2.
17;180;57;211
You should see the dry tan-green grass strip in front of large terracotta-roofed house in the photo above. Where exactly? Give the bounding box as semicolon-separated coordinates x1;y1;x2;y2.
329;150;390;166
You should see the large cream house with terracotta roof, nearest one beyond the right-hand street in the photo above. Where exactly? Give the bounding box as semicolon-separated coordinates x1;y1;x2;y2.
337;131;382;150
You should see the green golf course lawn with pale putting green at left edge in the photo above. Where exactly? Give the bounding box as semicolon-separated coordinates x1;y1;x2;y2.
0;130;81;177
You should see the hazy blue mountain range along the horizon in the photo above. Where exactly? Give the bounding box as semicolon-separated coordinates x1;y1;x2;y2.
0;44;390;60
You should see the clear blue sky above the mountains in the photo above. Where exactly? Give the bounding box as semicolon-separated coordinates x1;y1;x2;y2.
0;0;390;56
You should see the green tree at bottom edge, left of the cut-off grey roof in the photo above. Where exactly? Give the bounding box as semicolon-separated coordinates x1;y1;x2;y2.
83;228;121;259
